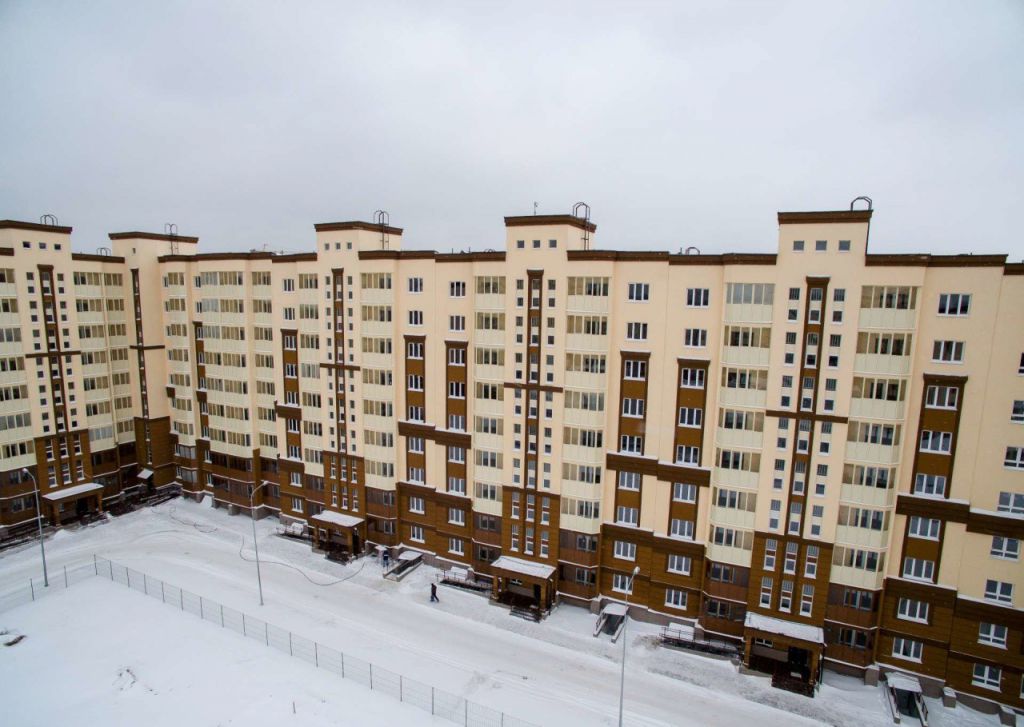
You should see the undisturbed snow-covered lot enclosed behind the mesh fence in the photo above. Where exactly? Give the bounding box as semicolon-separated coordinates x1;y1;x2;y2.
0;578;436;727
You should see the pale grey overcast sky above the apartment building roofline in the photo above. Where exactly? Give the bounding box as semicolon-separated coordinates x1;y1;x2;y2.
0;0;1024;258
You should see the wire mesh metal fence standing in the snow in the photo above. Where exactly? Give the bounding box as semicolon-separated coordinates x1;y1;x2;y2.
0;556;537;727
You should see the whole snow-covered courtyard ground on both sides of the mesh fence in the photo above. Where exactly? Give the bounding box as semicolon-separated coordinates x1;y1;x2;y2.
0;500;998;727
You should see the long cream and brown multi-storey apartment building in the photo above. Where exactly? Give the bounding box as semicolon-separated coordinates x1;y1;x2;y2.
0;210;1024;709
